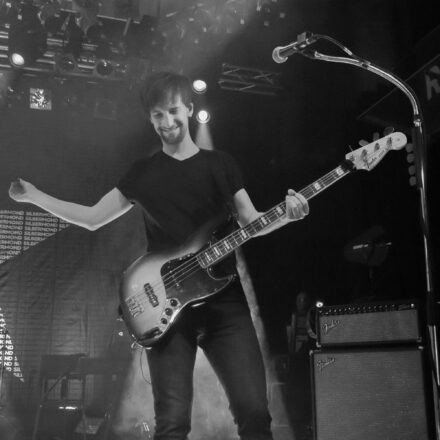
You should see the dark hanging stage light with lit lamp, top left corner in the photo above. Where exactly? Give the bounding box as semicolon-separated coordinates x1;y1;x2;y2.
8;3;46;68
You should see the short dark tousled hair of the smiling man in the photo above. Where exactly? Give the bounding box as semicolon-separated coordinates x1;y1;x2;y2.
140;72;192;114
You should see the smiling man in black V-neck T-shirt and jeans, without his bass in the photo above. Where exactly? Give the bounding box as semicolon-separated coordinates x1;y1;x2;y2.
9;72;309;440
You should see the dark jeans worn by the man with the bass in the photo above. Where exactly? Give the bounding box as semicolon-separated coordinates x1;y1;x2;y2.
147;286;272;440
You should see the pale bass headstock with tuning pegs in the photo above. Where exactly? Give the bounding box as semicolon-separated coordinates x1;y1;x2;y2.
345;132;407;171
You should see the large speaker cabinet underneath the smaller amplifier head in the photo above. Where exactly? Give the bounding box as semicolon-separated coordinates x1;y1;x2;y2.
311;348;430;440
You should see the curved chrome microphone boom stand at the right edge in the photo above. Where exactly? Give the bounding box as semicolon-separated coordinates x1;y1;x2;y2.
297;35;440;440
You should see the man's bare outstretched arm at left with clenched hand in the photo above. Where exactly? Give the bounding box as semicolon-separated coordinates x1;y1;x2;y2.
9;179;133;231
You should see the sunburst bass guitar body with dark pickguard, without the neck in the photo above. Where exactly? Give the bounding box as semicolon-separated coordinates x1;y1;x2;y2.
120;217;236;347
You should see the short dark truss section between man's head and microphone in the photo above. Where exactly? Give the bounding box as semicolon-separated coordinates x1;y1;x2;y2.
218;63;283;96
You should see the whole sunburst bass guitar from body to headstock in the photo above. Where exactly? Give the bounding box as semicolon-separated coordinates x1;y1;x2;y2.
120;132;407;347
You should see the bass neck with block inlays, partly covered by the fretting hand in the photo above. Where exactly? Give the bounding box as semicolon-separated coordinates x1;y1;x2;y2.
197;161;353;268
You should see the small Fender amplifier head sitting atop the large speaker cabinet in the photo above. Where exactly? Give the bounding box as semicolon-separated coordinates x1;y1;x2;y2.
316;301;422;347
